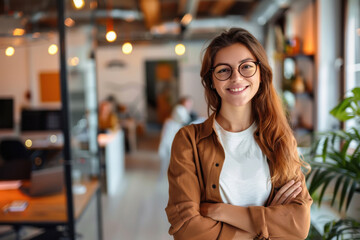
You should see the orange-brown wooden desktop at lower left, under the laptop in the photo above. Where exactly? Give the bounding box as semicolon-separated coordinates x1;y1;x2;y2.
0;180;99;225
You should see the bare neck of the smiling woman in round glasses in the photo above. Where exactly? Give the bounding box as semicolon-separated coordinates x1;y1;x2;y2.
216;104;253;132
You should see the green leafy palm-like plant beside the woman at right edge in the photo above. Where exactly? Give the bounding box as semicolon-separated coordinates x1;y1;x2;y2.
307;88;360;239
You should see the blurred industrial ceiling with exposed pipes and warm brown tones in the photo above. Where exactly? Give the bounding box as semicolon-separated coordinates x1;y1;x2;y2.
0;0;290;45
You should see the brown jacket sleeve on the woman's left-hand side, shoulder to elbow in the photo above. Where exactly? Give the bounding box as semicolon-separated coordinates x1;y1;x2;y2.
165;128;249;240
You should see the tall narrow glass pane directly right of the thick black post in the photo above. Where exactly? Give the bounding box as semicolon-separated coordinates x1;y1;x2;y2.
64;1;101;239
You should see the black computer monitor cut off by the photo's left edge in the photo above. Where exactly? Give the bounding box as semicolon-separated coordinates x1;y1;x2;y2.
0;98;14;130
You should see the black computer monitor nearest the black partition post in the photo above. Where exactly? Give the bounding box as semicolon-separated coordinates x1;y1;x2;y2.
21;109;62;131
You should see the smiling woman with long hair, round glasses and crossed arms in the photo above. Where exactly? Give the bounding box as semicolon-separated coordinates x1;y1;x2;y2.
166;28;312;240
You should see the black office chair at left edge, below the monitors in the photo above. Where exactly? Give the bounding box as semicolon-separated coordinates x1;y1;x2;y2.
0;139;32;180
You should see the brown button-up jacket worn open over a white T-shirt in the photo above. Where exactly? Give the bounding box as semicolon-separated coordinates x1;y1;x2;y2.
165;114;312;240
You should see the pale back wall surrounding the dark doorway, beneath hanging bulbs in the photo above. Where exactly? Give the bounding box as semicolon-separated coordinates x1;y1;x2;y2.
96;42;207;122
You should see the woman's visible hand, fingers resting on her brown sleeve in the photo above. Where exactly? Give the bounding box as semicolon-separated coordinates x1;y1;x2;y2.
270;180;302;206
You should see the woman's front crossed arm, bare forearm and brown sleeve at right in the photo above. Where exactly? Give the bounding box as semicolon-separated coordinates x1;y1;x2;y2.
205;173;312;239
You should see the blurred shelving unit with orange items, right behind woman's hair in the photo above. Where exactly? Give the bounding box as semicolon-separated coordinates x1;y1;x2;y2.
270;0;317;147
